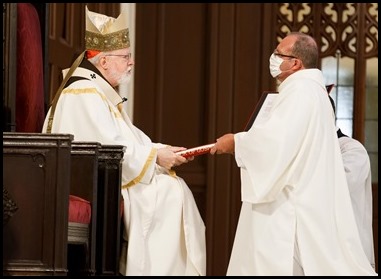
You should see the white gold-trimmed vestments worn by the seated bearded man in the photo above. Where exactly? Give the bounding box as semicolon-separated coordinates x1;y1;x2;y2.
43;68;206;275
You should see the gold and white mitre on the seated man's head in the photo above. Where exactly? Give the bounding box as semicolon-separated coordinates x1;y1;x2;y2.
85;6;130;51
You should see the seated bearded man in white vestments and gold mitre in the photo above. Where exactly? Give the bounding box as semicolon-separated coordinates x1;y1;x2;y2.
43;7;206;275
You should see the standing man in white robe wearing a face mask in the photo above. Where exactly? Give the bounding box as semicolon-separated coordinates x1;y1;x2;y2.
210;33;377;276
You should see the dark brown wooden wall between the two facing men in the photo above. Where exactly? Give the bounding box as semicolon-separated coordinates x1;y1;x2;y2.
134;3;276;275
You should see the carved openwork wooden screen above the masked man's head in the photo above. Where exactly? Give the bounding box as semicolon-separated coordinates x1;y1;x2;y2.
276;3;378;59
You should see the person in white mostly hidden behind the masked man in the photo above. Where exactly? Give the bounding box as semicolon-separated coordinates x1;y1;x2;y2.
328;95;376;268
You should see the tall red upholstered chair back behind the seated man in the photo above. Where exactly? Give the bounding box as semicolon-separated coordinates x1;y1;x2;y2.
16;3;45;133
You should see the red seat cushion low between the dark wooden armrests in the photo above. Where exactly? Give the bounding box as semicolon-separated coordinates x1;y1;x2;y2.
69;195;91;224
